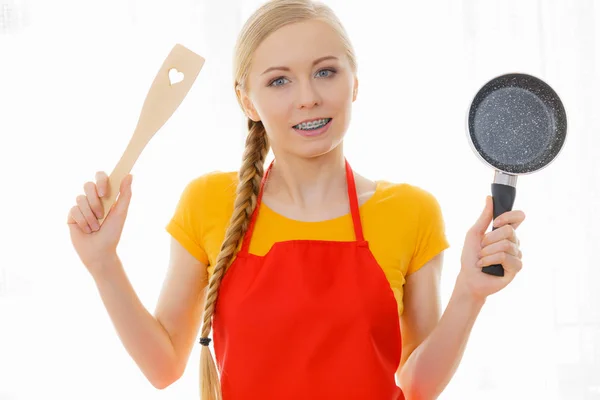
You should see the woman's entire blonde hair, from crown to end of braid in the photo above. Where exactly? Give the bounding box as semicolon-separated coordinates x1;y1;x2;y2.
200;0;357;400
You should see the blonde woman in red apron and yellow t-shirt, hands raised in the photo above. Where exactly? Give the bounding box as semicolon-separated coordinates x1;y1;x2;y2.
68;0;525;400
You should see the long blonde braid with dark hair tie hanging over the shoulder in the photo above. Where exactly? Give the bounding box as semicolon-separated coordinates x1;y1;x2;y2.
200;119;269;400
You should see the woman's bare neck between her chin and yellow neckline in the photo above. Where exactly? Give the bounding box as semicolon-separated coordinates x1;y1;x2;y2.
266;144;347;208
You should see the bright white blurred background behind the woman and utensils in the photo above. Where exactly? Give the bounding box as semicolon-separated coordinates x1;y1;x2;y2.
0;0;600;400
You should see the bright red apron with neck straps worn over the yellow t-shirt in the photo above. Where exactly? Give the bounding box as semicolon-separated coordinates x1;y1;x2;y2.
213;161;404;400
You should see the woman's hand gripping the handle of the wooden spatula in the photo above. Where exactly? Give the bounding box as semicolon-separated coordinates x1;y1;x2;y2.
67;172;132;275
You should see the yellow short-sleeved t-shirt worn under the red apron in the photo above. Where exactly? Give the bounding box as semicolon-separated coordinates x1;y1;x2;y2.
166;172;449;315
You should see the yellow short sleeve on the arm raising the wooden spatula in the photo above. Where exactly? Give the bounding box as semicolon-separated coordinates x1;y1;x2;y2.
165;176;208;265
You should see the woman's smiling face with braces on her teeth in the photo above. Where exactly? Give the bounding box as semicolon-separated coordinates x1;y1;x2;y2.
240;20;358;158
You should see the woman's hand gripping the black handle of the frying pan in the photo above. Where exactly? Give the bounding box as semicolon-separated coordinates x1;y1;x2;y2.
456;196;525;301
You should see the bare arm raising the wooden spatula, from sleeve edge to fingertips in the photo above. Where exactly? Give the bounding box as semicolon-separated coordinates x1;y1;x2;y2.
67;172;208;389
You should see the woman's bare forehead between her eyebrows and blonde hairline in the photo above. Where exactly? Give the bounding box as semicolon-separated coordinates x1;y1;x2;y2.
251;20;345;75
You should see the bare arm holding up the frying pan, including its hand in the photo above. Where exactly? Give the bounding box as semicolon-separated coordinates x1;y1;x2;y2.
397;197;525;400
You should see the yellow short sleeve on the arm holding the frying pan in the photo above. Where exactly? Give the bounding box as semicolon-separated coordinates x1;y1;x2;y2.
406;188;450;275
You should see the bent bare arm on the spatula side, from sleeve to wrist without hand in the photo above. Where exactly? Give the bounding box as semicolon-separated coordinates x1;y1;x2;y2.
94;239;208;389
